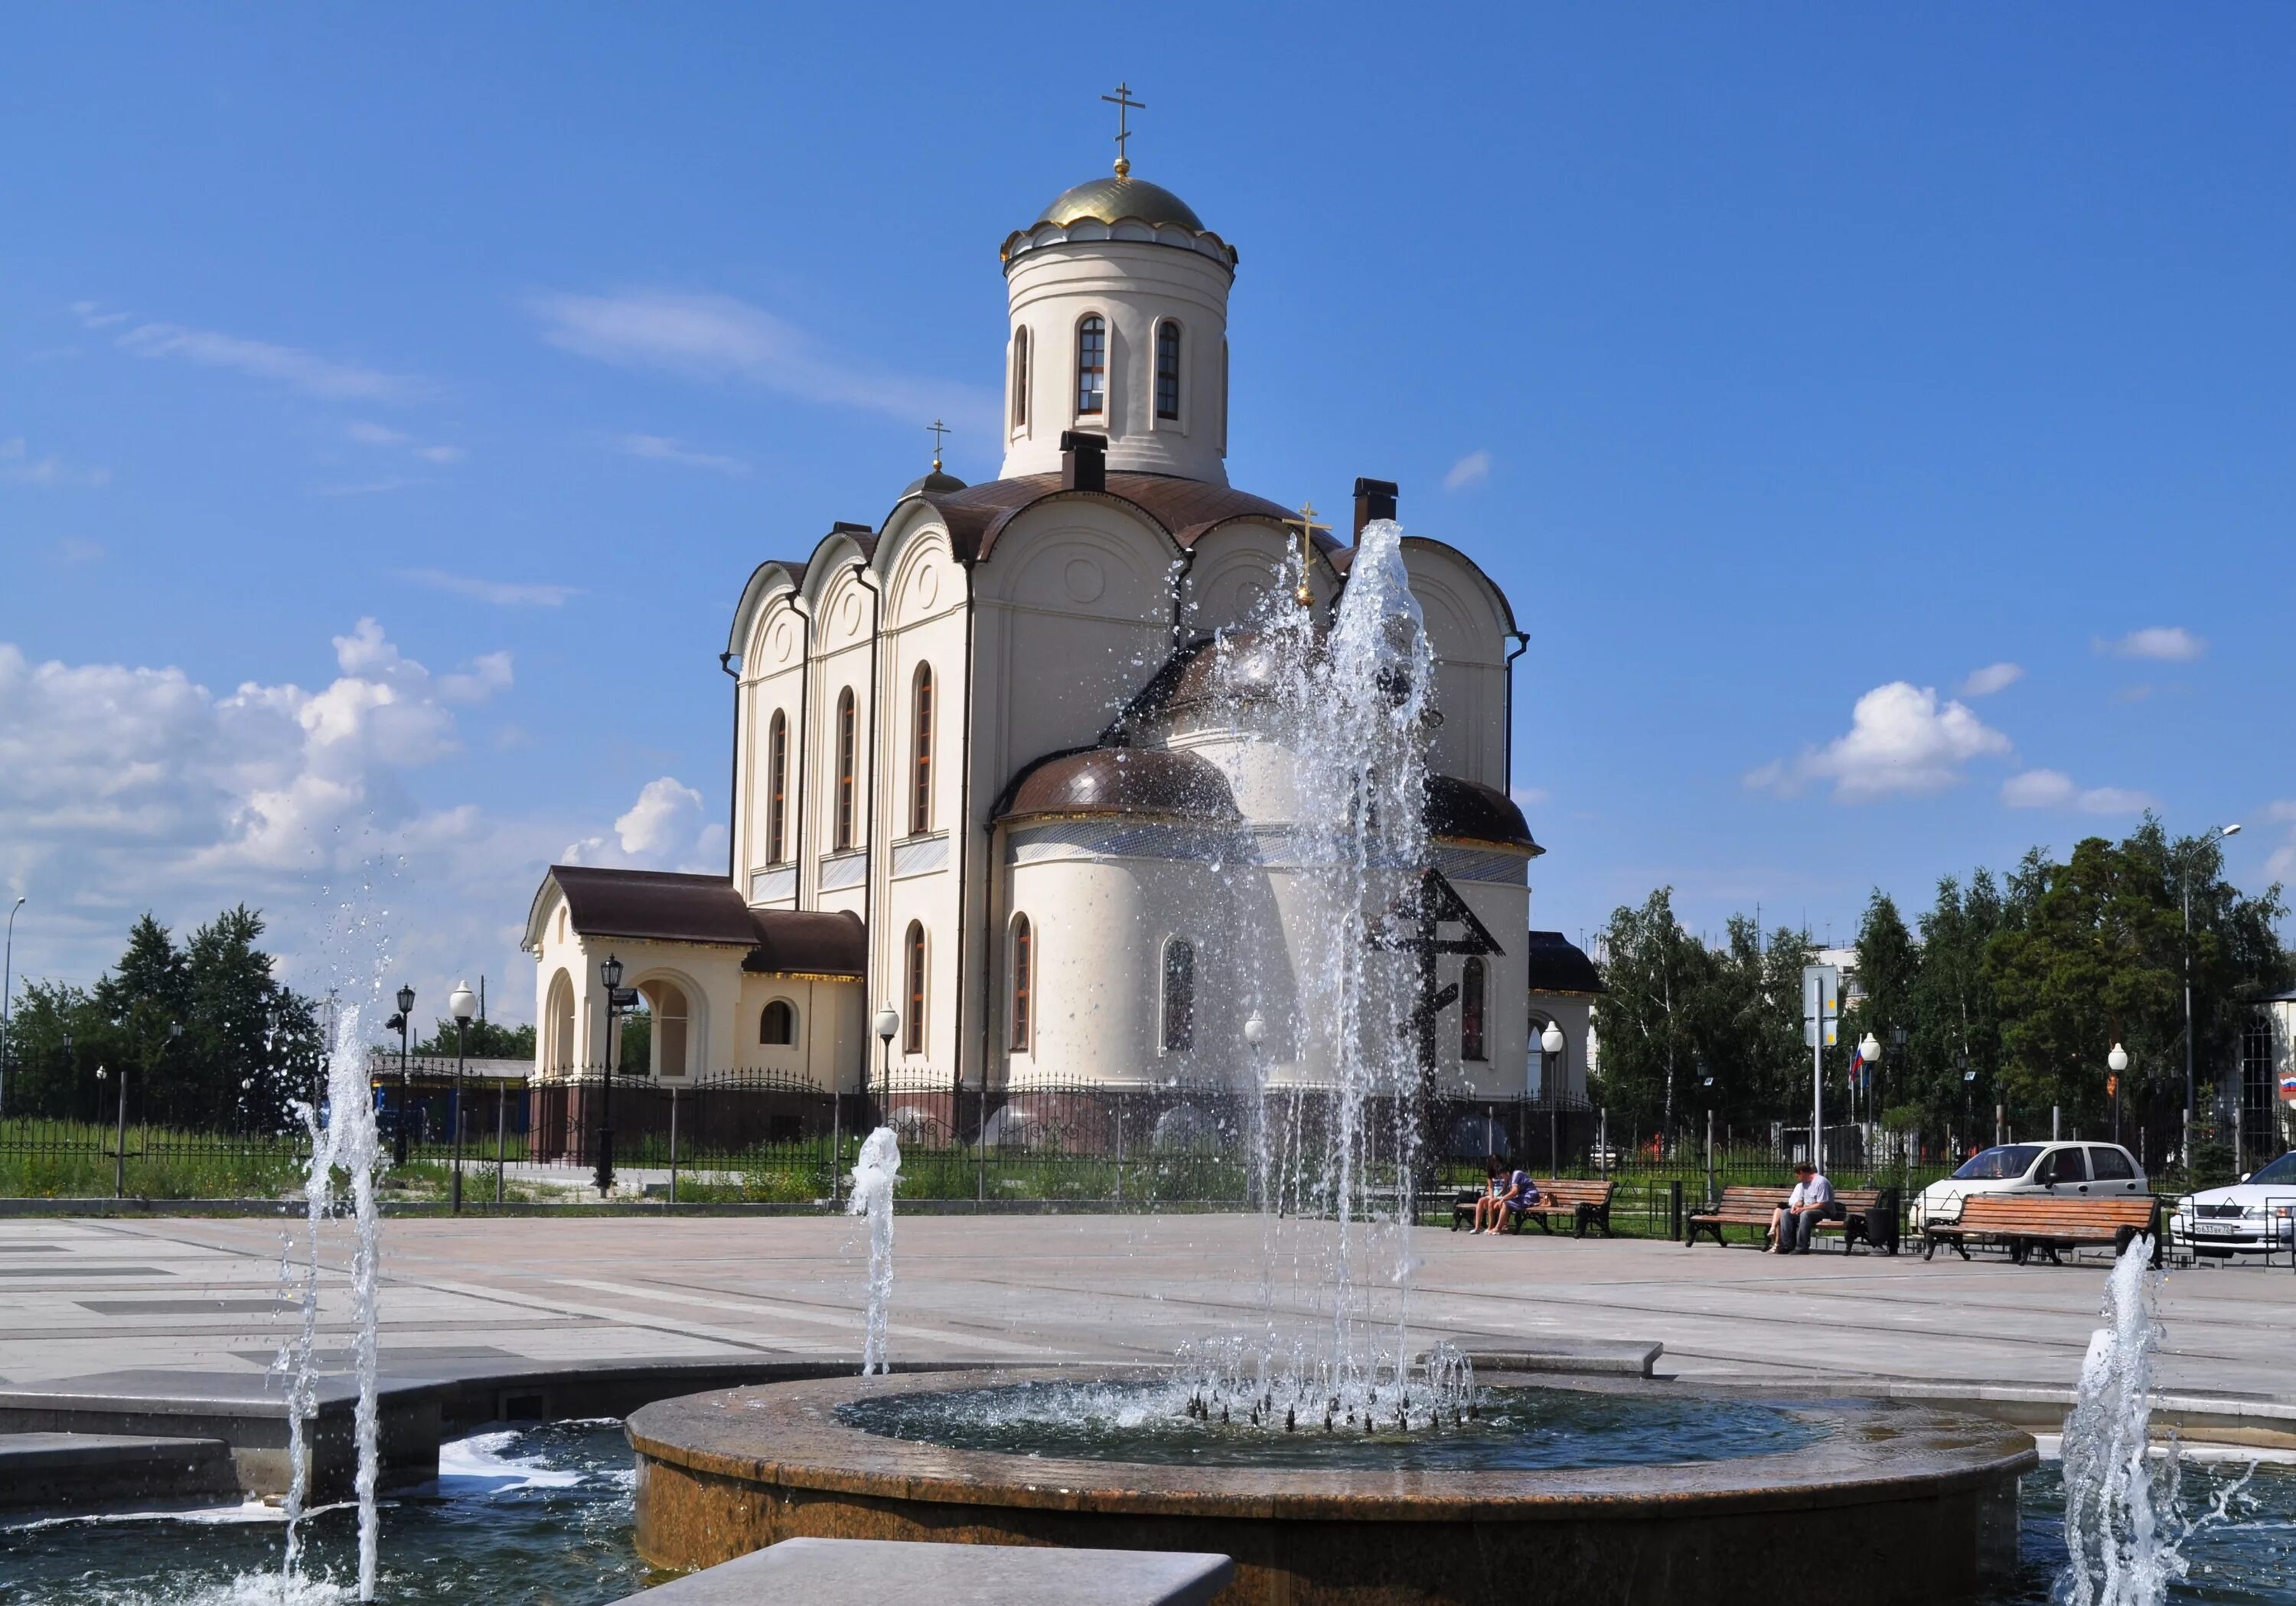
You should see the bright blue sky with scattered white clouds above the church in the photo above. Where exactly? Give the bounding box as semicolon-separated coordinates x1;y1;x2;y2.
0;5;2296;1020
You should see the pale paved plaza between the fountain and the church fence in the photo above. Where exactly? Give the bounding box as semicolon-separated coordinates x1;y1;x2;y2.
0;1216;2296;1409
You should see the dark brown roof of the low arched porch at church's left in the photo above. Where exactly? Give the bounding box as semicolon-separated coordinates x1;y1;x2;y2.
549;864;866;977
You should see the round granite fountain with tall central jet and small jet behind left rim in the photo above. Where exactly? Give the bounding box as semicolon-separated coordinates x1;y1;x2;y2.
627;521;2034;1606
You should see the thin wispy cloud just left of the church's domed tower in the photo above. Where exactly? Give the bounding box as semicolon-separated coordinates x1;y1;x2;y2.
528;289;996;427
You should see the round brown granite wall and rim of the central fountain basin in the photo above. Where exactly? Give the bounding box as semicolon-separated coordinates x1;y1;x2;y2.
627;1372;2037;1606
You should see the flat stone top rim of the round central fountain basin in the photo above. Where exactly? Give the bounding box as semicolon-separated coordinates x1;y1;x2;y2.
625;1367;2039;1521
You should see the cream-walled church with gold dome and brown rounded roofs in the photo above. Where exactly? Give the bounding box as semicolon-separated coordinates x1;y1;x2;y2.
523;129;1593;1116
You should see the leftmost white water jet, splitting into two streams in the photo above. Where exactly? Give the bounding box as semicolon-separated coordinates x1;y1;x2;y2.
278;1004;381;1601
